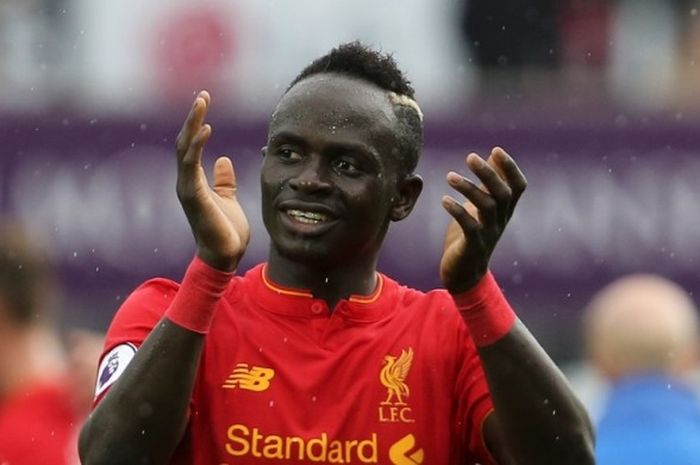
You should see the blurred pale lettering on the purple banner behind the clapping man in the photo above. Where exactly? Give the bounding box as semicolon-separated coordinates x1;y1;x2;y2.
6;147;700;276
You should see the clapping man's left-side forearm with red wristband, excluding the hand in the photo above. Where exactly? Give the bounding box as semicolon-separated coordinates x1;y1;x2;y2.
80;258;232;465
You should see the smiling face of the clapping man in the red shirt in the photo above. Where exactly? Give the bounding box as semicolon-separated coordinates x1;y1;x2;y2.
261;74;410;264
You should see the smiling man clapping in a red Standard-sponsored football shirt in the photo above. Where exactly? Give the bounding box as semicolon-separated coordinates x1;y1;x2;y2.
80;43;592;465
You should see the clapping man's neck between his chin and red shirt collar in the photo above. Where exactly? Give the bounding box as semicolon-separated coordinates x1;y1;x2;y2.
267;246;377;309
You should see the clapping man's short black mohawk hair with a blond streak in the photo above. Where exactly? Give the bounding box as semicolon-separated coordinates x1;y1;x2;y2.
287;41;423;176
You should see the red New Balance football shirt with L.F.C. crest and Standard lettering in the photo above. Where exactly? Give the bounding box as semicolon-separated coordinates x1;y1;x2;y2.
97;265;493;465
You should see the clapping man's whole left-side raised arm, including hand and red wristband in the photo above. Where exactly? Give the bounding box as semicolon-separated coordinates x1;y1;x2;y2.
79;91;250;465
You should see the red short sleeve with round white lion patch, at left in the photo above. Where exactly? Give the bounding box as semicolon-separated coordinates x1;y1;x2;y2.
94;278;179;405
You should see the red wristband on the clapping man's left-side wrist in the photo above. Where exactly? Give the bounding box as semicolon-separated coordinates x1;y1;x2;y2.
165;256;233;334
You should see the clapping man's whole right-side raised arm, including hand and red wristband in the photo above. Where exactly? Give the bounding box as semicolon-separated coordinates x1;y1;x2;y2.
440;148;595;465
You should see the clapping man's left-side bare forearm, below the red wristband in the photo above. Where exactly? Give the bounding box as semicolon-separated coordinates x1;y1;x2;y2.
79;318;204;465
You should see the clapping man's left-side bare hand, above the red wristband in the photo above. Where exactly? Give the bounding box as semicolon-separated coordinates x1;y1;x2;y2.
176;91;250;271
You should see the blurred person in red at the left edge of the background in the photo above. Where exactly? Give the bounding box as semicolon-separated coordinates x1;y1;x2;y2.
0;220;101;465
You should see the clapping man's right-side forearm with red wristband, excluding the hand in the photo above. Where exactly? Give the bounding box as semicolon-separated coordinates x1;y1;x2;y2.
453;273;593;465
